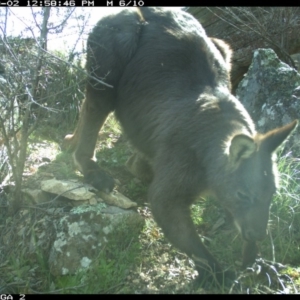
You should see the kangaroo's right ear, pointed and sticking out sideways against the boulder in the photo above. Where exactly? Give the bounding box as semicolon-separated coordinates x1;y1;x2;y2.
260;120;298;153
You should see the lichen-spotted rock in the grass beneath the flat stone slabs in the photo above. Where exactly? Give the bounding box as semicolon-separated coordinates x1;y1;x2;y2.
49;203;144;276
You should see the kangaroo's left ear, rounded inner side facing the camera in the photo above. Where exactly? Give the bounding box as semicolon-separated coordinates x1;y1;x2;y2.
229;134;256;163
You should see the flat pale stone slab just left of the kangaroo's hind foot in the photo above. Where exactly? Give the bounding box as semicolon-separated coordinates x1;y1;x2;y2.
41;179;95;200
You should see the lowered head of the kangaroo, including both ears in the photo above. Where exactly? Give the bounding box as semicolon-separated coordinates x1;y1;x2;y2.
217;121;298;241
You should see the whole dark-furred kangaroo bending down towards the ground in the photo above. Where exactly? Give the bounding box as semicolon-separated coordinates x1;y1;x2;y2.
65;7;297;281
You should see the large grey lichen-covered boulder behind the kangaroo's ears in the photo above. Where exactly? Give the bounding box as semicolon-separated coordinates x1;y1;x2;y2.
236;49;300;150
